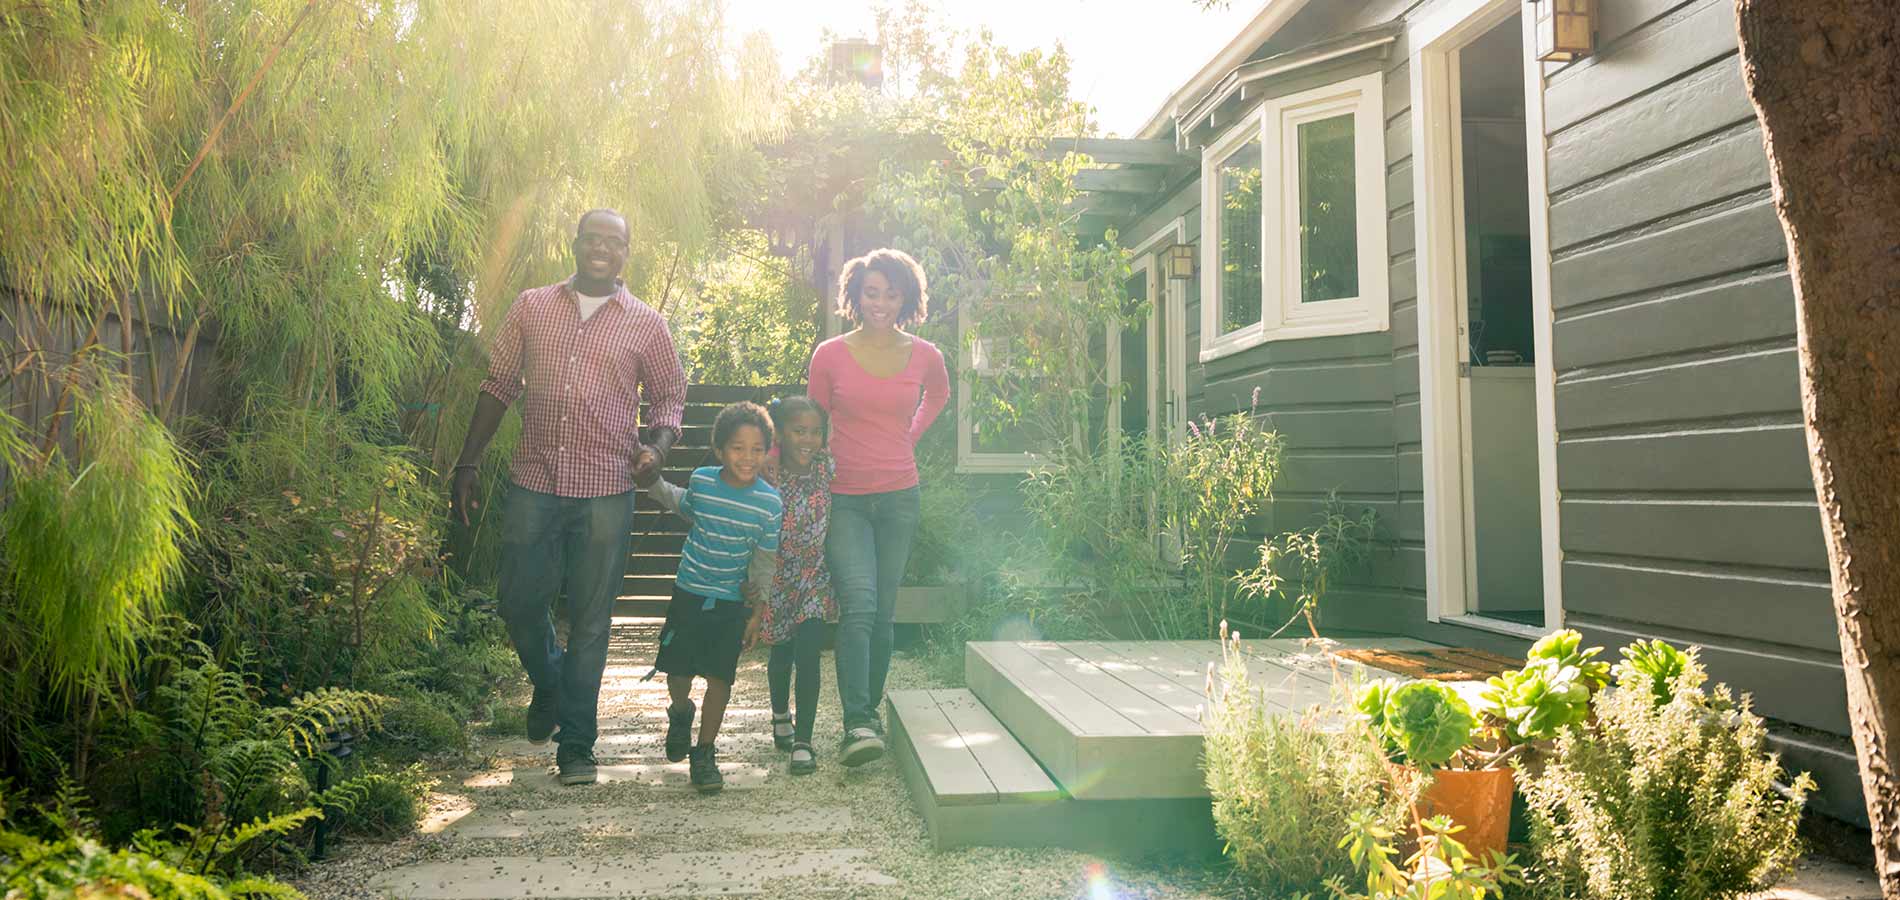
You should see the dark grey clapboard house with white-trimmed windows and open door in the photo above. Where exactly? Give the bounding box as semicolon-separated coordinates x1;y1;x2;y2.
1086;0;1866;822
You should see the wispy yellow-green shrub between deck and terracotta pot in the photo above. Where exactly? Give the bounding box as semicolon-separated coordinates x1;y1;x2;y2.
1203;634;1417;896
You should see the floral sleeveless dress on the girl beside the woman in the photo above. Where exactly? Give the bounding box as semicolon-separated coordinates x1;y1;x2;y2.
760;450;838;644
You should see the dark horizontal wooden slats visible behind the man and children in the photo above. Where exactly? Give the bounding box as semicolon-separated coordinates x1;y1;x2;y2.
614;384;804;617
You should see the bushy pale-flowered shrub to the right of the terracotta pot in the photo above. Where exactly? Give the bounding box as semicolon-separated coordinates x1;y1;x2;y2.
1520;647;1813;900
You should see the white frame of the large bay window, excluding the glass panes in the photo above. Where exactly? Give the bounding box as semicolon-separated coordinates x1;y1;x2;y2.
1201;72;1391;363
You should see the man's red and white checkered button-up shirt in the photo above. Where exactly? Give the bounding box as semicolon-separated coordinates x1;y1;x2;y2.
481;281;686;497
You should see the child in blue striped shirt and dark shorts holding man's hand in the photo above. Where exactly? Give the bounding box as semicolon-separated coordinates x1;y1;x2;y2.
640;403;785;794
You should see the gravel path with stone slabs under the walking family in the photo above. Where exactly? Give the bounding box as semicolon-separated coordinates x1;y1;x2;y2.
296;619;1239;900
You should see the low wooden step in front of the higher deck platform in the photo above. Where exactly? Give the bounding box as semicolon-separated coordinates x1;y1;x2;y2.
885;689;1220;856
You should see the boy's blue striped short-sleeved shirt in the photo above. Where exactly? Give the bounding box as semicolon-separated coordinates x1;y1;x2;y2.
675;465;785;600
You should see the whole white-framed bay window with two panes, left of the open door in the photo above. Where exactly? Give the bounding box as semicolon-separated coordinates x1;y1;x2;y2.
1201;74;1391;361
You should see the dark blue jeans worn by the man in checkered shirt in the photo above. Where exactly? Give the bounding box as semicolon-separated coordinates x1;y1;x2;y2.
496;484;633;750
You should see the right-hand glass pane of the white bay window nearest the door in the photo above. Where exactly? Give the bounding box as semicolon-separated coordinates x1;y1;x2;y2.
1300;114;1359;304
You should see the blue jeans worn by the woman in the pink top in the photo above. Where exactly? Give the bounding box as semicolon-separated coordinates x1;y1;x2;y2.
825;488;918;729
